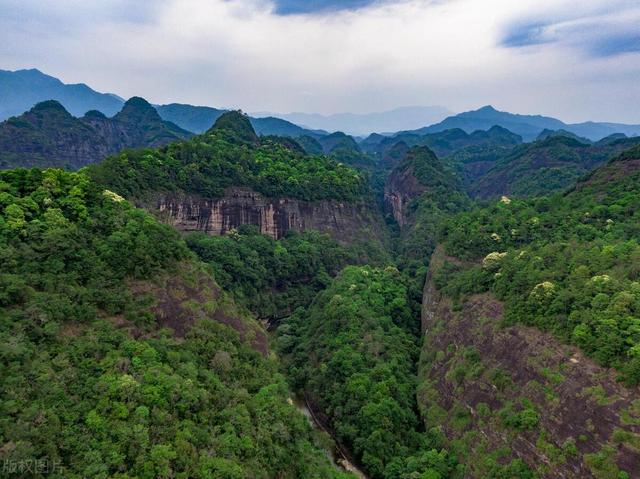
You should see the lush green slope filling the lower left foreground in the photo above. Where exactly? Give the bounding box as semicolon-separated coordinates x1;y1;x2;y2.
0;170;350;479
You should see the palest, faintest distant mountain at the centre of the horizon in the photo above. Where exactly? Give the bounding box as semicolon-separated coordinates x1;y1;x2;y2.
254;106;451;136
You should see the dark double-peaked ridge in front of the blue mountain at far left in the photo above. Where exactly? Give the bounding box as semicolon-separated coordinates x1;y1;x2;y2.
0;97;192;169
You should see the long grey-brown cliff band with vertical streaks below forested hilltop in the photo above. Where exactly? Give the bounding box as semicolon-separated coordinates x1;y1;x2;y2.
151;187;385;242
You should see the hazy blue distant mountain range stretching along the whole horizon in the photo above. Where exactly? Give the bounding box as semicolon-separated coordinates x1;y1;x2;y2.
0;69;640;141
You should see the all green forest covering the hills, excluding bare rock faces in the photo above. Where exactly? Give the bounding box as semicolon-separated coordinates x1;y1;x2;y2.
0;104;640;479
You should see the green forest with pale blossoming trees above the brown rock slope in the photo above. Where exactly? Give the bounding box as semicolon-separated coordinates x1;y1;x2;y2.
440;148;640;384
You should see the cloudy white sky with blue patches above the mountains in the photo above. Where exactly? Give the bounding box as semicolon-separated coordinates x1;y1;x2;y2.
0;0;640;123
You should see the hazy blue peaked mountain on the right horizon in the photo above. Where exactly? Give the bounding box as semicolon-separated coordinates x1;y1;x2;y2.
408;105;640;141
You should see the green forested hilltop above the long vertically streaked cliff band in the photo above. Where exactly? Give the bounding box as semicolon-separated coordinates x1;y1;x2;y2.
89;111;369;201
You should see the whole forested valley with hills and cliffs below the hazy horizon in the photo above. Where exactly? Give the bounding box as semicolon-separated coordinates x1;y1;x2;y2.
0;71;640;479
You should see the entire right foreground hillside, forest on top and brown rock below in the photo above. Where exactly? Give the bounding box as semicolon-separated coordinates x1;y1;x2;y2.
419;147;640;478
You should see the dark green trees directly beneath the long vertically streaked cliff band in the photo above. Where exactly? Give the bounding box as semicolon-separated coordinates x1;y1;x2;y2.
187;226;387;319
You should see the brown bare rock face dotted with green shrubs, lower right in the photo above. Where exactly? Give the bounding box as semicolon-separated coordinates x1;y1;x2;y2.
418;248;640;478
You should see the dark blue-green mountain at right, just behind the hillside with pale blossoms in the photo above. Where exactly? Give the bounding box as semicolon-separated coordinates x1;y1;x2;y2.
469;135;640;198
